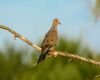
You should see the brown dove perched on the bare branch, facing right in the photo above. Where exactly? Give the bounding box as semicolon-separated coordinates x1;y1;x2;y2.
37;18;61;64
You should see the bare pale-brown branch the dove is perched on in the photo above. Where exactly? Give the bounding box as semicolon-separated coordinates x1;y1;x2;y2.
0;25;100;67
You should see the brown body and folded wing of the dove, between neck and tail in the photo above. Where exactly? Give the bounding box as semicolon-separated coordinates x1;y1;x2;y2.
41;29;58;52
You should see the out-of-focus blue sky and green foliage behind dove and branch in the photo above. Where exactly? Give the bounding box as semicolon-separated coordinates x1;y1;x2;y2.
0;0;100;80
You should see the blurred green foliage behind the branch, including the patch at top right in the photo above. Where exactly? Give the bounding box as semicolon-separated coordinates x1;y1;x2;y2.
0;0;100;80
